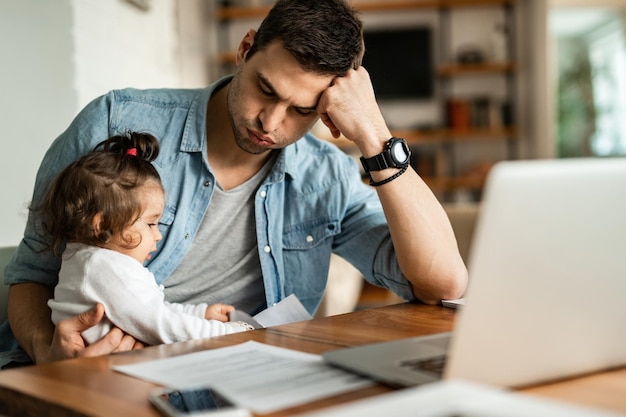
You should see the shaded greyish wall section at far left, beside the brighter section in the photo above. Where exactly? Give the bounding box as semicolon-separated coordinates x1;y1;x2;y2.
0;0;76;246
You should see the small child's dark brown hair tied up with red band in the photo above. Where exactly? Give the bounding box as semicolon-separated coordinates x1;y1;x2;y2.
31;132;163;254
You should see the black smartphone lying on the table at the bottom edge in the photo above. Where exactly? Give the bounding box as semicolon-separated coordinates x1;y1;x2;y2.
150;387;250;417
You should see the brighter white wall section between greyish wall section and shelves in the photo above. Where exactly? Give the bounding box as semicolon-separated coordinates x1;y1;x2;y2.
72;0;179;107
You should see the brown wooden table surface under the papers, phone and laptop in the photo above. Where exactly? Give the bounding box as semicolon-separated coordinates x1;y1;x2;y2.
0;303;626;417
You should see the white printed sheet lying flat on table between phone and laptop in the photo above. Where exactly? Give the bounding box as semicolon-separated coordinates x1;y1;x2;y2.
113;341;373;413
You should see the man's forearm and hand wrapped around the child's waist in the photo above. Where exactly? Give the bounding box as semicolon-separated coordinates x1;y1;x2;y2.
8;283;143;363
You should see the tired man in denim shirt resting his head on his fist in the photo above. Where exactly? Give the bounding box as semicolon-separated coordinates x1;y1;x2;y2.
3;0;467;363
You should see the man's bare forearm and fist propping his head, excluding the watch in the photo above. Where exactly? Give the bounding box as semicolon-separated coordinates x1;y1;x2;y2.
318;67;467;303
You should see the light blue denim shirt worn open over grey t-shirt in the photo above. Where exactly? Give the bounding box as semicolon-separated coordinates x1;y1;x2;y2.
5;77;414;313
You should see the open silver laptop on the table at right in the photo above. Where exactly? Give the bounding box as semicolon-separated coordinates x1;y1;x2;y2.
323;158;626;387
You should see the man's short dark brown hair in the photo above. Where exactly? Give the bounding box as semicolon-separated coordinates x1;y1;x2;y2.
246;0;364;76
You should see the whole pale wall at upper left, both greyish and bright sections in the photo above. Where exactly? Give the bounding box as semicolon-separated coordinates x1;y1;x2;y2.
0;0;206;246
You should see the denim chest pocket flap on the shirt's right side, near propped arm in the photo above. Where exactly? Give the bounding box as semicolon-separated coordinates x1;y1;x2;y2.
283;219;341;250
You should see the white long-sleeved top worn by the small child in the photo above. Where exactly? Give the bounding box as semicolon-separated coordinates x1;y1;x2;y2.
48;243;246;345
